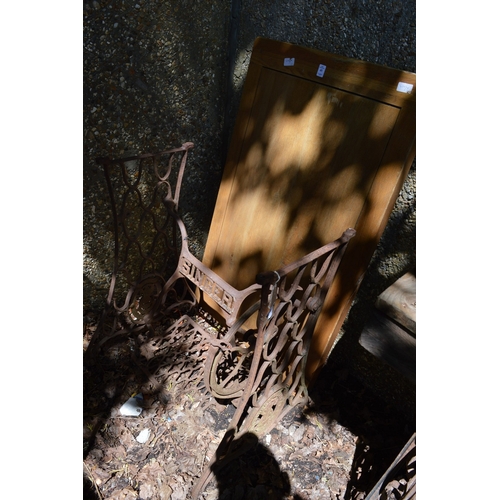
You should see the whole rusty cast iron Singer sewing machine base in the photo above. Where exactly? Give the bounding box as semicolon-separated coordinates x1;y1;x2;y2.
89;142;355;498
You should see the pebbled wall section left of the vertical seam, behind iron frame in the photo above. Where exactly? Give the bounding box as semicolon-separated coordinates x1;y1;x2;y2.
83;0;230;311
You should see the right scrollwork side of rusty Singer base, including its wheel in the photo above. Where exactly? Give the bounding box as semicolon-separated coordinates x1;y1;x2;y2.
193;229;356;498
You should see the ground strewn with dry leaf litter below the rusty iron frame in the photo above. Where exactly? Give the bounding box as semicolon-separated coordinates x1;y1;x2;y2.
83;321;415;500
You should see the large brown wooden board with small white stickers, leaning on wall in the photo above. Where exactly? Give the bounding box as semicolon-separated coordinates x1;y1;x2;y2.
203;38;416;380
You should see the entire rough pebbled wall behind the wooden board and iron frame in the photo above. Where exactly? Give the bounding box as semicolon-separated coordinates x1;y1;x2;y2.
84;0;416;410
